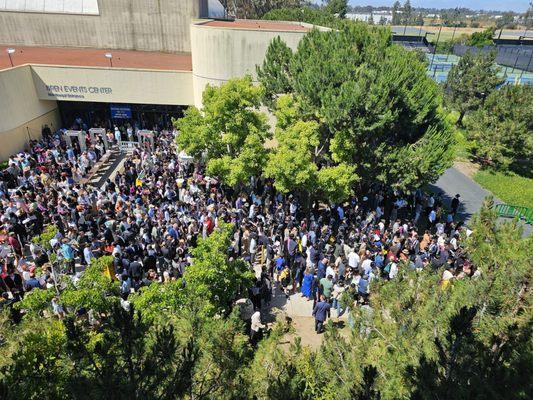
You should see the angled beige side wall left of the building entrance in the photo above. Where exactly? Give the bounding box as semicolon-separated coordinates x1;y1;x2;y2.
0;66;60;160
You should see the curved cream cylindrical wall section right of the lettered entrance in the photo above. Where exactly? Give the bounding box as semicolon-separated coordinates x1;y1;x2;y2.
191;21;316;106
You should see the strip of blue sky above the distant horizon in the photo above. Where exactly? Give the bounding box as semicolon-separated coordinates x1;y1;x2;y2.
340;0;530;12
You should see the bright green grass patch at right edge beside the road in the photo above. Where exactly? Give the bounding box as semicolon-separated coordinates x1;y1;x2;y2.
474;170;533;208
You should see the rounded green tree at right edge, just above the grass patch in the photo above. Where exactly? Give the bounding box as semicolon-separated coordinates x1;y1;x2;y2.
466;85;533;171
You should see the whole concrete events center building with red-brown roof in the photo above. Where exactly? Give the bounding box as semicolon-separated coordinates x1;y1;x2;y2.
0;0;320;160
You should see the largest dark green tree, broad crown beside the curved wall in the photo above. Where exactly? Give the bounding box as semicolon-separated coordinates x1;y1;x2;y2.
259;23;452;189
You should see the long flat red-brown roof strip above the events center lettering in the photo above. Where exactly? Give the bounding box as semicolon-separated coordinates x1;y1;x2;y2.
0;46;192;71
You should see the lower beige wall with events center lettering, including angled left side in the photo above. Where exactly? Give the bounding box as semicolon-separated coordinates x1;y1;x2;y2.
0;65;194;160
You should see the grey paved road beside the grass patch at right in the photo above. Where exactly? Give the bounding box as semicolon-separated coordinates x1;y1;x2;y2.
429;167;533;236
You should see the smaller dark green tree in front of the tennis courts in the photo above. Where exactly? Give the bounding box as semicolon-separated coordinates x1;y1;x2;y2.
444;52;504;126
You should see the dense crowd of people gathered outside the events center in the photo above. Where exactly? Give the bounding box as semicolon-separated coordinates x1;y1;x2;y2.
0;122;474;340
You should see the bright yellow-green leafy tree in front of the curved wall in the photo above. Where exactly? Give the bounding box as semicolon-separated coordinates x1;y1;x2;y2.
174;76;270;186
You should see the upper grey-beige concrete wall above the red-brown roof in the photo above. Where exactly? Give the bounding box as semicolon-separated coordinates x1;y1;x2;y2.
0;0;206;52
